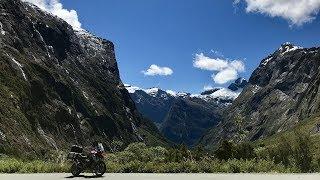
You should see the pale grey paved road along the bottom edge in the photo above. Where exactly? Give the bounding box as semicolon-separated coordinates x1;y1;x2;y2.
0;174;320;180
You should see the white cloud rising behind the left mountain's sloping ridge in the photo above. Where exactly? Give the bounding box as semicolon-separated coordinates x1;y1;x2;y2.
22;0;81;29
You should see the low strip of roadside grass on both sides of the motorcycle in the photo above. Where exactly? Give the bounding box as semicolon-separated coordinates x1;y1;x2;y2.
0;158;298;173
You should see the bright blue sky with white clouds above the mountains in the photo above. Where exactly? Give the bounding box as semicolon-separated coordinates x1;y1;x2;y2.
24;0;320;93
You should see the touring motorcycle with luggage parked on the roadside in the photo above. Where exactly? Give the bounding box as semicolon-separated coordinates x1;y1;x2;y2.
68;143;106;177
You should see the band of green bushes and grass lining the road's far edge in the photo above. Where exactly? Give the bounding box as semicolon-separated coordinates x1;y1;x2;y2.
0;131;320;173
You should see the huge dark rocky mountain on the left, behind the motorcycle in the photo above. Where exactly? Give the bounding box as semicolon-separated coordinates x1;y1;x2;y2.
0;0;169;155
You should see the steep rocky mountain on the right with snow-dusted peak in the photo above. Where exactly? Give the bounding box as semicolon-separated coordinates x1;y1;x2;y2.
201;43;320;148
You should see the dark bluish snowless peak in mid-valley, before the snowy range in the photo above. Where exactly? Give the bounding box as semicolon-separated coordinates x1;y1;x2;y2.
160;97;223;146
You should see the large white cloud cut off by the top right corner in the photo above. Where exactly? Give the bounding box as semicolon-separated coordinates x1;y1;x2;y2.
234;0;320;26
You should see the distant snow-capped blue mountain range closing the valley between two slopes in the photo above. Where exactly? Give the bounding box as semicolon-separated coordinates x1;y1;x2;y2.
126;79;246;147
